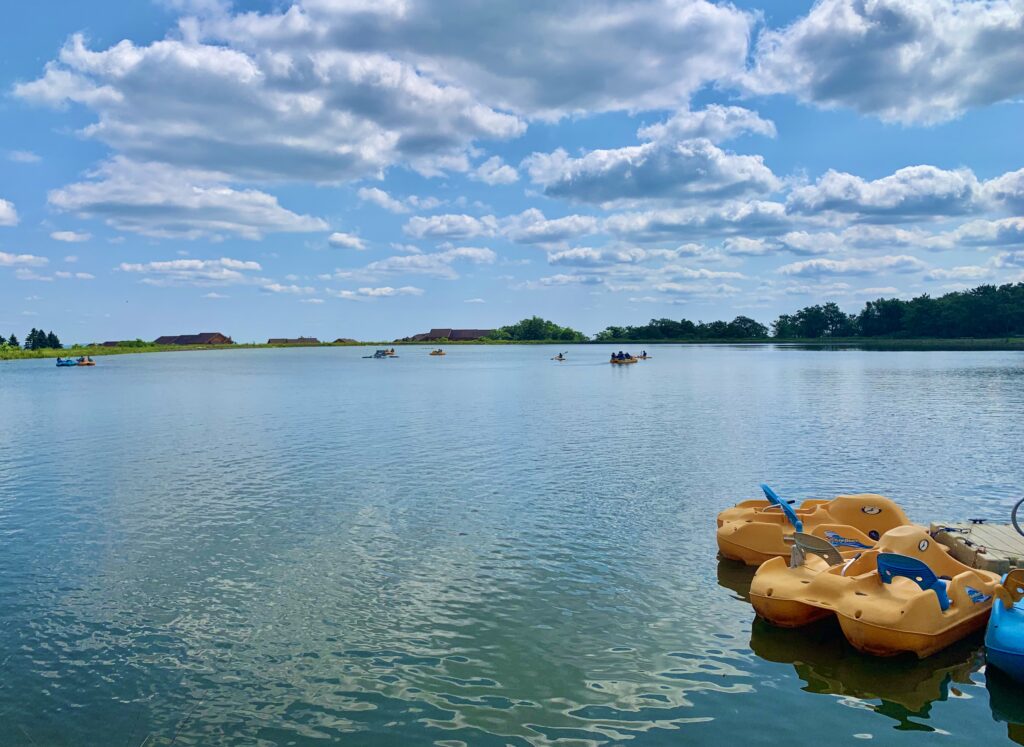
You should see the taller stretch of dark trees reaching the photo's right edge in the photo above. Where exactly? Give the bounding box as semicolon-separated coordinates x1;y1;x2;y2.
772;283;1024;338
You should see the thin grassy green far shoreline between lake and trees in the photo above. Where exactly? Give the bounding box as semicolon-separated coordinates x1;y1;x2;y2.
0;337;1024;361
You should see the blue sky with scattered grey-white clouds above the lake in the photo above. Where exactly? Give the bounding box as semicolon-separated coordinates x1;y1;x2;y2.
0;0;1024;341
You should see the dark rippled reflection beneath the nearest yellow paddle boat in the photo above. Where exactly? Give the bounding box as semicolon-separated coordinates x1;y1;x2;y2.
751;619;981;723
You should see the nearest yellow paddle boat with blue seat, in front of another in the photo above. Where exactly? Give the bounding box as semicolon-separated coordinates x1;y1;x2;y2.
751;527;998;658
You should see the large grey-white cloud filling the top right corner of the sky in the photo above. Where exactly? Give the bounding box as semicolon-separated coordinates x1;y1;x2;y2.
744;0;1024;124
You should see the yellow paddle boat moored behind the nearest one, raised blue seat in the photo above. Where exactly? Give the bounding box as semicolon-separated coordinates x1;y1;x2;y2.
718;485;910;566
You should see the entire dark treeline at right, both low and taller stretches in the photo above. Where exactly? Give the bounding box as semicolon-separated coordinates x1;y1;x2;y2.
594;283;1024;342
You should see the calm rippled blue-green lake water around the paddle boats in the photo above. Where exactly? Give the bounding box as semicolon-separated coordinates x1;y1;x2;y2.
0;346;1024;747
